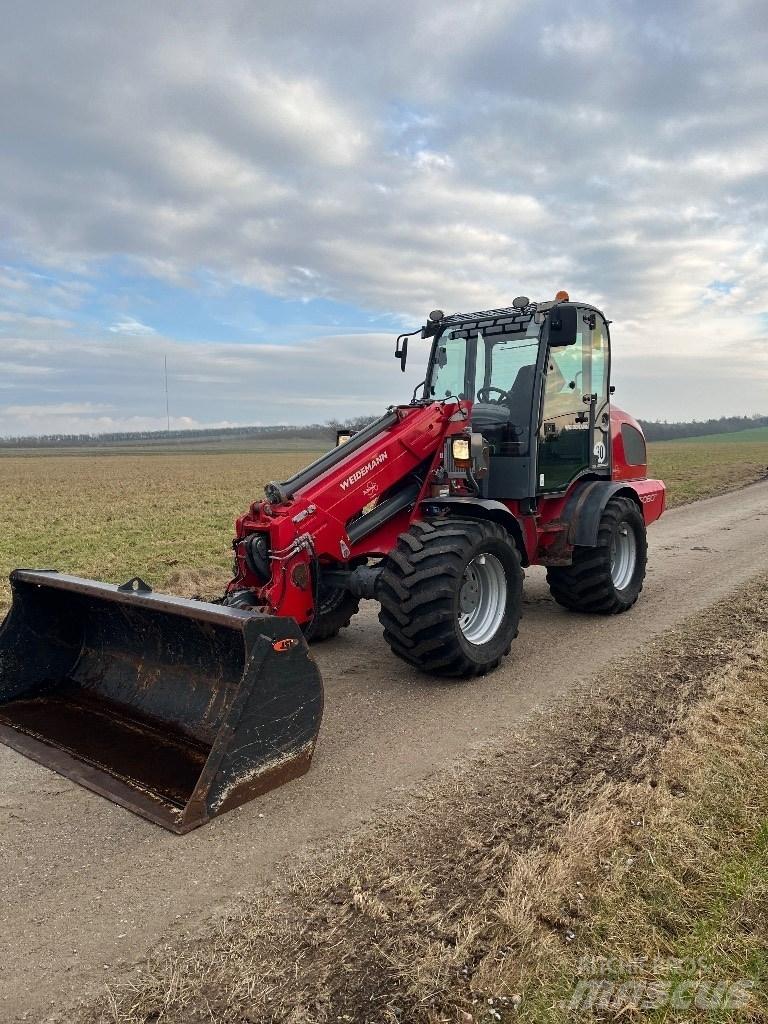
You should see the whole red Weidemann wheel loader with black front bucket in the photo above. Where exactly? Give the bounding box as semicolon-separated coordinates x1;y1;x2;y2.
0;293;665;833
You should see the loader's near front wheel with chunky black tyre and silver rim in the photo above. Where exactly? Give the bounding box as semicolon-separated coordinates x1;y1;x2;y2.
378;519;523;677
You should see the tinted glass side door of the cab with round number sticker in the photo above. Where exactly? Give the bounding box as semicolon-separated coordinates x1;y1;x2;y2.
537;307;610;494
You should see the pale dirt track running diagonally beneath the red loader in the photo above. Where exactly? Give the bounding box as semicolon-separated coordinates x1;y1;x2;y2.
0;482;768;1022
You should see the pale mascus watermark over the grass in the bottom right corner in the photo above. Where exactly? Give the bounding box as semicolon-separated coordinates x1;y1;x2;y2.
564;956;755;1013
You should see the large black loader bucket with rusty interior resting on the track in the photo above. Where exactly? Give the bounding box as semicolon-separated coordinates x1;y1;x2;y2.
0;569;323;833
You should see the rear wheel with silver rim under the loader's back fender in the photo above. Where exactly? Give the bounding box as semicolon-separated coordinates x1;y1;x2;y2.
547;498;648;615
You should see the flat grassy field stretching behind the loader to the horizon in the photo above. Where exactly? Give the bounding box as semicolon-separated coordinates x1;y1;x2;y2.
0;435;768;611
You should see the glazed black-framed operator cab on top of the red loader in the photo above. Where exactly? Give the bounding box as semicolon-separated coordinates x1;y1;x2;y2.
423;299;610;500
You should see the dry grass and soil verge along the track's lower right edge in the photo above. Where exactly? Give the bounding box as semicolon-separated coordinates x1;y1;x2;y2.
66;579;768;1024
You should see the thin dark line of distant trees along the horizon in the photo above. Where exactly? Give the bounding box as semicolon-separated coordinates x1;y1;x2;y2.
0;416;768;449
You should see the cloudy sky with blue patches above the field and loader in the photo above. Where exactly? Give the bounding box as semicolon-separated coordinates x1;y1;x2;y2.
0;0;768;435
